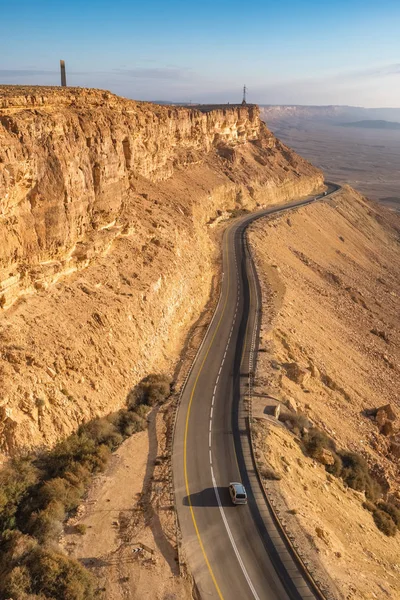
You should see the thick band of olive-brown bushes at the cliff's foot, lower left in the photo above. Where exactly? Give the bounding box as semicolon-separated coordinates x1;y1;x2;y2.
0;375;171;600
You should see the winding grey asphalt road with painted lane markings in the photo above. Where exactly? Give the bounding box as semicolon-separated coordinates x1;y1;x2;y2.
173;185;338;600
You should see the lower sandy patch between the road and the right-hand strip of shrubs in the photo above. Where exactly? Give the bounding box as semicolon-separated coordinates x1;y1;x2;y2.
255;420;400;600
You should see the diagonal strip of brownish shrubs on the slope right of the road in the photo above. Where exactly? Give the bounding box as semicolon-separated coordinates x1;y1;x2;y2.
280;413;400;536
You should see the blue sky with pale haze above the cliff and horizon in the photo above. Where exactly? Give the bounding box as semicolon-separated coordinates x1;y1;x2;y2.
0;0;400;107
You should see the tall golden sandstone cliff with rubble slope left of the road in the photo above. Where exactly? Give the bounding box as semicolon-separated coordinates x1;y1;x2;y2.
0;83;322;453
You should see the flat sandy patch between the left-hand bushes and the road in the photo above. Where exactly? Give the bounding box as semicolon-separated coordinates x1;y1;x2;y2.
63;412;192;600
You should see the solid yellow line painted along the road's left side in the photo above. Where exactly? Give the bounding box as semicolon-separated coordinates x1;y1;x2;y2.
183;226;232;600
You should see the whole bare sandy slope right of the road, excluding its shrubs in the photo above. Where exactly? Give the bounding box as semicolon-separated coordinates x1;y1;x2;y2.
250;190;400;600
